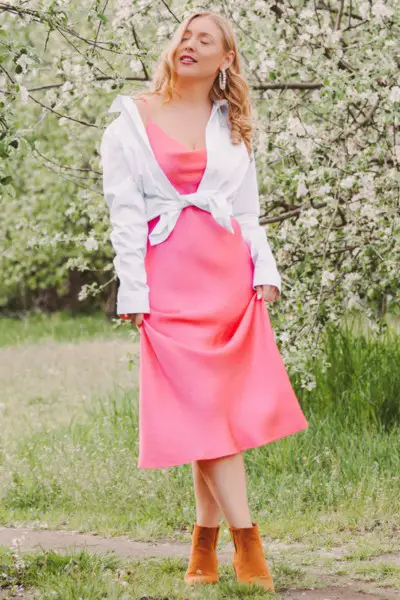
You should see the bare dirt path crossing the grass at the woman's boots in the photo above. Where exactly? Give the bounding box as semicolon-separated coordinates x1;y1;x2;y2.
0;527;400;600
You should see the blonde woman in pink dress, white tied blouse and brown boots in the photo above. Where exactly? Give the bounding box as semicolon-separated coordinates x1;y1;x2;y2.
101;11;308;591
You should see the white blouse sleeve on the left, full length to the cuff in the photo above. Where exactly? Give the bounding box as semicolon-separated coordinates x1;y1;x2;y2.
100;123;150;318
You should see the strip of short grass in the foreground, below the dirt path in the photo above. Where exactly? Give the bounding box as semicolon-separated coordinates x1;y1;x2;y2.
0;534;400;600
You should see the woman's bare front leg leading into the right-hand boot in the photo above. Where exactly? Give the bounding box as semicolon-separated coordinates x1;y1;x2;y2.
197;452;252;527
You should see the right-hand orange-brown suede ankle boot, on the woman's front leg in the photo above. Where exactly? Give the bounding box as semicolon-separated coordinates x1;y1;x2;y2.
229;523;275;592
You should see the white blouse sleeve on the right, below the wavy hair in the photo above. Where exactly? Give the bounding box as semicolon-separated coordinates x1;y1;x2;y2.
233;150;282;293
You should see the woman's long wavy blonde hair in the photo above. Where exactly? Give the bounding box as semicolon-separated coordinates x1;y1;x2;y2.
133;10;253;156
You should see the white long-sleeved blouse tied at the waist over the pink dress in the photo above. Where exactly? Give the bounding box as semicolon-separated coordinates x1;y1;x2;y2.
100;95;281;315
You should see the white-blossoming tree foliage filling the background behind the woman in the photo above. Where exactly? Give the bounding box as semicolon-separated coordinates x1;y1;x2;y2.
0;0;400;388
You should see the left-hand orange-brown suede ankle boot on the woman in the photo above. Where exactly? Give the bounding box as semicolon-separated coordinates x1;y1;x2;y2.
184;523;219;584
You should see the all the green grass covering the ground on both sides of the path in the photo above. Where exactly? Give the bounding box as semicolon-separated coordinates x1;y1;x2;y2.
0;315;400;599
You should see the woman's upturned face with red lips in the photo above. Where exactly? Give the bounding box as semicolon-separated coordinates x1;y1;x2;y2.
175;16;234;81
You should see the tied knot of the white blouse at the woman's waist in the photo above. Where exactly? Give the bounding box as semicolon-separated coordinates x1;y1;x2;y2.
148;191;235;246
